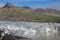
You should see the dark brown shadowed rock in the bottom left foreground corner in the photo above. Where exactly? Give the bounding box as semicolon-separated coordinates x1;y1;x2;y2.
0;30;31;40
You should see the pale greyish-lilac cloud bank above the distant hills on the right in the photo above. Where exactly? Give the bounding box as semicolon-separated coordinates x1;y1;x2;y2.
32;2;60;10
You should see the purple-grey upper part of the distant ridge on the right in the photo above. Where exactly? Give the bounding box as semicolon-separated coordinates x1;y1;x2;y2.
34;8;60;14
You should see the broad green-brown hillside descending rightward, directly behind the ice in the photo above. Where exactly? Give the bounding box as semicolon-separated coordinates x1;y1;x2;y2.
0;3;60;22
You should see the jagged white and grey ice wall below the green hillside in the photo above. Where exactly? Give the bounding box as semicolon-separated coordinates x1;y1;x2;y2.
0;21;60;37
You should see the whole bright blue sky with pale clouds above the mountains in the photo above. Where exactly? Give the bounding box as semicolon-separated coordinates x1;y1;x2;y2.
0;0;60;9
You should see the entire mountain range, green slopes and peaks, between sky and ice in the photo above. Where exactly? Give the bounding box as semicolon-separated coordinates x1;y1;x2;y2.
0;3;60;22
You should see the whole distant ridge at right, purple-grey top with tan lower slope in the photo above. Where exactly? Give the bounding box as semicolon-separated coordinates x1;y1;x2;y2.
34;8;60;16
